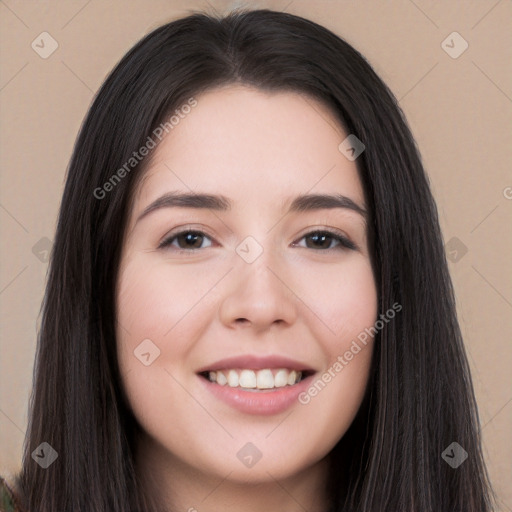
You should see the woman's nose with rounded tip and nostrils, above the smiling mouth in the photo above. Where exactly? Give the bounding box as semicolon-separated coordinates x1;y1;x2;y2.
220;250;297;332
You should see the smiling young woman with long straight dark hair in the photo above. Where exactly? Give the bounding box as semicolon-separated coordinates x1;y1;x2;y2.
1;10;492;512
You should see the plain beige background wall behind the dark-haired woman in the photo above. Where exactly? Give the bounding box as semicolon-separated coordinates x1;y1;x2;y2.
0;0;512;511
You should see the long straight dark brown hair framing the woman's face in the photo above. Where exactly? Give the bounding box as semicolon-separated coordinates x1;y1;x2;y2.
19;10;492;512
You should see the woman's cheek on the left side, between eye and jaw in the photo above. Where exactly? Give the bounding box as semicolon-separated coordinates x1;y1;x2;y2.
116;253;229;424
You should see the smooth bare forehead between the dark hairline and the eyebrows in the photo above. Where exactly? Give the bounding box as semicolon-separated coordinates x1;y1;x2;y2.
130;85;364;218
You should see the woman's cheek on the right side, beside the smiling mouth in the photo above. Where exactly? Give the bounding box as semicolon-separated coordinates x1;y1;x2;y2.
299;257;378;428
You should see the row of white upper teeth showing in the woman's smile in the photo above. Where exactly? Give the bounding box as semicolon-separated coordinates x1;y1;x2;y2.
208;368;302;389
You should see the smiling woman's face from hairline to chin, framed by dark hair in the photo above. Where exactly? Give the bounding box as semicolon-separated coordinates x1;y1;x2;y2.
116;86;377;490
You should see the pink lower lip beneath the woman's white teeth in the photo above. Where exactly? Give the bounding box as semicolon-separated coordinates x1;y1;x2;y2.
199;375;312;416
